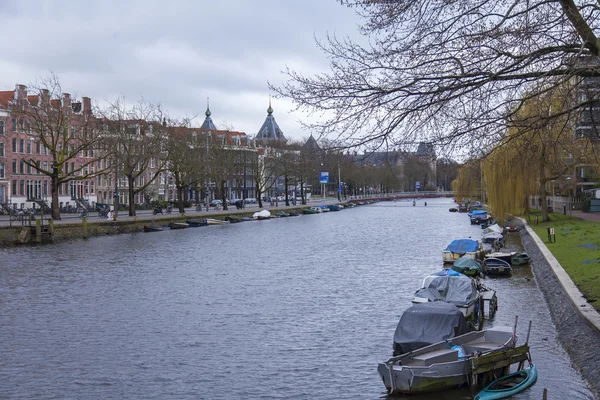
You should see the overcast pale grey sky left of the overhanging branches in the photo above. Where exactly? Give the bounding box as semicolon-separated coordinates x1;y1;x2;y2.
0;0;360;140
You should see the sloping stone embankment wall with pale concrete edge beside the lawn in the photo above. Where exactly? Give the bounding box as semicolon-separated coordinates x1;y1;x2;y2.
521;224;600;398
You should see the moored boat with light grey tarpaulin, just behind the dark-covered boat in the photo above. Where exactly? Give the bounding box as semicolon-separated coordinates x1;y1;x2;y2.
412;269;480;321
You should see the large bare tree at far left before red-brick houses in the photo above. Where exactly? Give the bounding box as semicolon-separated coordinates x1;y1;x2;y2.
9;75;107;220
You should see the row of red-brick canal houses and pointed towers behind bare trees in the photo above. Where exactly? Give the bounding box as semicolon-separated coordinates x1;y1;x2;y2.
0;84;286;210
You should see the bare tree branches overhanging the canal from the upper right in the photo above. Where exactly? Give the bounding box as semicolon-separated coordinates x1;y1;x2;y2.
273;0;600;152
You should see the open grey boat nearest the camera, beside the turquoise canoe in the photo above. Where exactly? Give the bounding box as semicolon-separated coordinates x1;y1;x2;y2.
377;327;516;394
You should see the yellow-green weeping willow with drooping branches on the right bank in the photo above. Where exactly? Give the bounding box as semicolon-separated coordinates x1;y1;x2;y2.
482;81;590;221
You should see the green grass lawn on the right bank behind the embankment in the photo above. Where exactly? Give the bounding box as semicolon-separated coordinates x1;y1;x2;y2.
529;212;600;311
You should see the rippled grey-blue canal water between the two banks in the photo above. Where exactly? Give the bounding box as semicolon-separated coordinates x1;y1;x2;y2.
0;199;594;400
